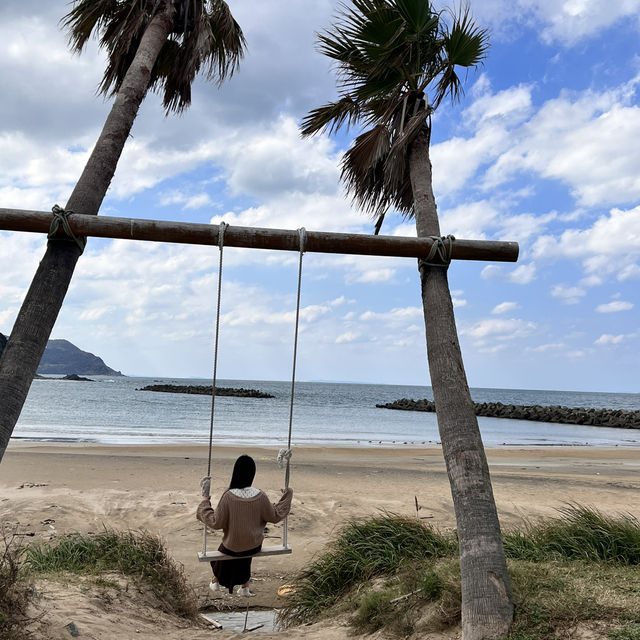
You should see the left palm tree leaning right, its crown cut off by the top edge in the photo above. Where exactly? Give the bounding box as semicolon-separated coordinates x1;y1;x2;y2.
0;0;245;461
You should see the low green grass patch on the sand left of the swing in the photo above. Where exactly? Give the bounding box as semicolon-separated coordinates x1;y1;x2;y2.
26;529;197;617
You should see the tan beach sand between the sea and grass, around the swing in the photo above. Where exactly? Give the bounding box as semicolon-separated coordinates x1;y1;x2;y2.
0;442;640;640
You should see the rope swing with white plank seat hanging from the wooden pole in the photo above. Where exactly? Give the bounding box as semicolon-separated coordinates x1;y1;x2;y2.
198;222;307;562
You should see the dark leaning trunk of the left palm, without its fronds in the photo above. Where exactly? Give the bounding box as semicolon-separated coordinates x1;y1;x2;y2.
0;5;173;461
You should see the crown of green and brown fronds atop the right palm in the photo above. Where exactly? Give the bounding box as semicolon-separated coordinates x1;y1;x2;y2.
302;0;488;222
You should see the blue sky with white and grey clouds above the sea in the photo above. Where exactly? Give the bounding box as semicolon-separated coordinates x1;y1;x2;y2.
0;0;640;393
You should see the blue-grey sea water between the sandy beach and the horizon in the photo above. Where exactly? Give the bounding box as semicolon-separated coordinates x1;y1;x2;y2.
13;376;640;447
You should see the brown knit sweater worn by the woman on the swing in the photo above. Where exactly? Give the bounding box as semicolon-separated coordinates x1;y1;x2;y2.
196;487;293;552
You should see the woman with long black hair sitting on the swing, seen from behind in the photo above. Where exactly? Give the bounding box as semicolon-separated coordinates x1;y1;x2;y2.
196;455;293;596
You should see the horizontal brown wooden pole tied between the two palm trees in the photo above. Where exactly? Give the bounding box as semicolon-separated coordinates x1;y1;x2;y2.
0;208;519;262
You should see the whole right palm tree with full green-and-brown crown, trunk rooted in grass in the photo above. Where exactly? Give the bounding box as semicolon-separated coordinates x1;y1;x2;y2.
302;0;513;640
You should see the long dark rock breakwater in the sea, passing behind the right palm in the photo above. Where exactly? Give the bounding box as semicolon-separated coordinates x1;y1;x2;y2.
376;398;640;429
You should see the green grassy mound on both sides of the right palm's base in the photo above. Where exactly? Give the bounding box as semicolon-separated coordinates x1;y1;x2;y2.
279;505;640;640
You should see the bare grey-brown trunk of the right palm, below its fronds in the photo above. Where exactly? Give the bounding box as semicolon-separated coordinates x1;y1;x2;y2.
409;133;513;640
